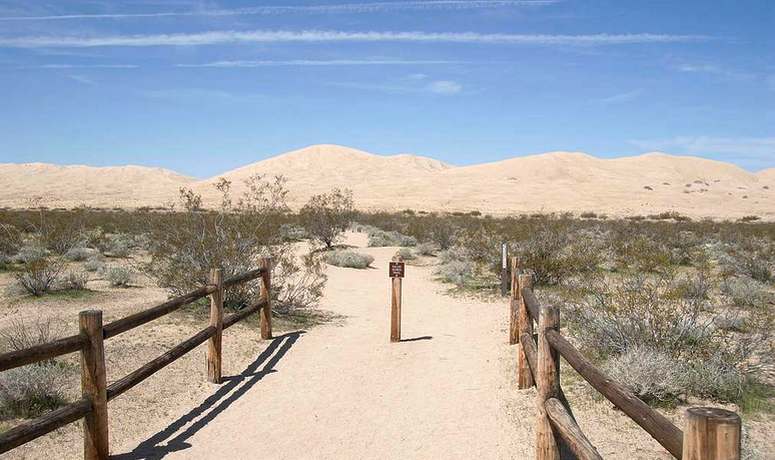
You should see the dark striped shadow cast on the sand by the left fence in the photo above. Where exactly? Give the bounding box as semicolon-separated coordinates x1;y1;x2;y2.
110;331;306;460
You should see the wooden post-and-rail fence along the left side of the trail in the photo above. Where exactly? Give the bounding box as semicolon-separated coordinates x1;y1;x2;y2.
0;258;272;460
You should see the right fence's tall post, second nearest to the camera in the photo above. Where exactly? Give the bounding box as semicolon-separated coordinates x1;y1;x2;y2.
535;305;560;460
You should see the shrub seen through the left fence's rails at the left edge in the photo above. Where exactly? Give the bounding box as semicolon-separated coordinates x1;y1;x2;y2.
0;319;68;418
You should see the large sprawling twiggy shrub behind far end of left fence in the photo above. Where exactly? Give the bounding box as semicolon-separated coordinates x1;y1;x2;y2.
143;176;325;308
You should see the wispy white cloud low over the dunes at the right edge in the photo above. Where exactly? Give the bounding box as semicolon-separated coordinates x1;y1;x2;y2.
630;136;775;172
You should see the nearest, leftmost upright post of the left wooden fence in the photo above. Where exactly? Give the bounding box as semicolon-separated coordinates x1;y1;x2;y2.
78;310;109;460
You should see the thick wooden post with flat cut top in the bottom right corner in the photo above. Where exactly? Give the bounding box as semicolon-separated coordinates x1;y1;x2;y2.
682;407;741;460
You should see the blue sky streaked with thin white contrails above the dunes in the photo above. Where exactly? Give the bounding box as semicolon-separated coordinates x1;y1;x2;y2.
0;0;775;177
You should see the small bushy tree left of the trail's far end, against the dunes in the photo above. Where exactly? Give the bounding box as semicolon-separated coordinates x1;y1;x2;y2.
299;188;354;248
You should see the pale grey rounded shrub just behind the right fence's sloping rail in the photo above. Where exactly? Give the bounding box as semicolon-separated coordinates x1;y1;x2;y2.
603;347;691;403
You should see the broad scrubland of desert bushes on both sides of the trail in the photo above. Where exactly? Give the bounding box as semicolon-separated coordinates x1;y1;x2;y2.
0;177;775;458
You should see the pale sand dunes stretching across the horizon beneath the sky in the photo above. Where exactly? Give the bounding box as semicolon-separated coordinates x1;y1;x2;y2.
0;145;775;220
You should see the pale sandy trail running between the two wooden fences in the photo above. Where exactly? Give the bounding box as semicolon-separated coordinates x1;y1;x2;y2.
113;235;533;459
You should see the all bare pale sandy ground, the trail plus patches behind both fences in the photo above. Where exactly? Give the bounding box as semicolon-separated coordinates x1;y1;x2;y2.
0;234;775;459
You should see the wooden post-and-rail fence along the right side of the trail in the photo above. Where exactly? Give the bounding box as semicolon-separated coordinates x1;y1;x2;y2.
509;257;741;460
